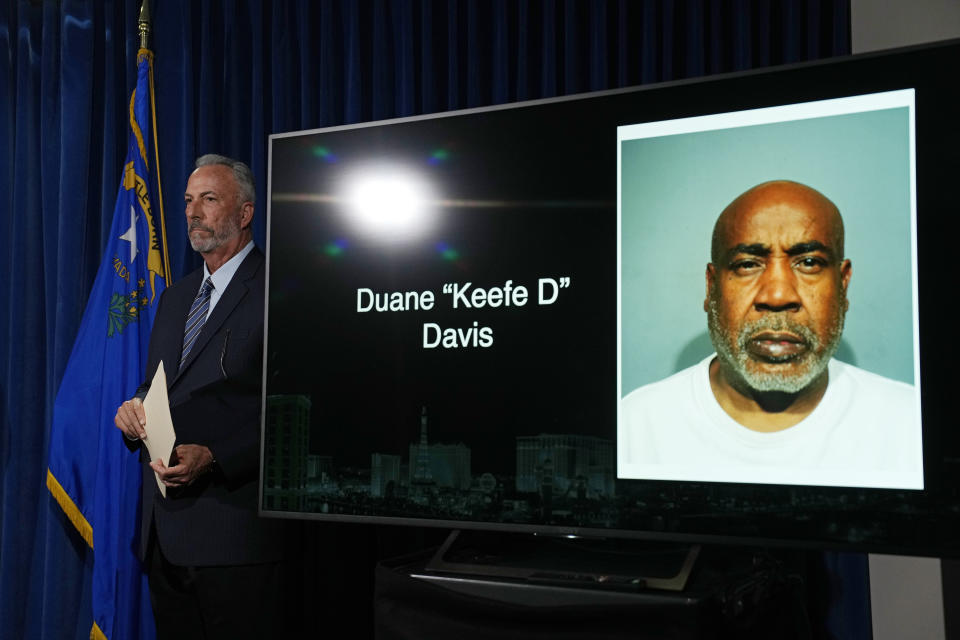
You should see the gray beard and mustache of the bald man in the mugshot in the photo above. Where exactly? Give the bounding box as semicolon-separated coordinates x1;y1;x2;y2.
707;295;844;393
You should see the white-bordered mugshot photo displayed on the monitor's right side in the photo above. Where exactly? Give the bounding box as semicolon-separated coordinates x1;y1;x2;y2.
617;90;923;489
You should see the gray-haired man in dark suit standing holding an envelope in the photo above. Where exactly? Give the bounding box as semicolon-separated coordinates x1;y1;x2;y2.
115;155;281;639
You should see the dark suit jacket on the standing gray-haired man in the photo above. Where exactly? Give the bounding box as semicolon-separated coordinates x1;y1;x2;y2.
138;248;281;566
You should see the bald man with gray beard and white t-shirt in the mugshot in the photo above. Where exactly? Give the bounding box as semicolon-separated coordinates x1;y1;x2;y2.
620;180;922;487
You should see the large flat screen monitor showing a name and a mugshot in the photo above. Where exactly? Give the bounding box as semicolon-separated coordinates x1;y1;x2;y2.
260;42;960;555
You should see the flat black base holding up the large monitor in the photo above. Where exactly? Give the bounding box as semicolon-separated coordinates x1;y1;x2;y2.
424;530;700;591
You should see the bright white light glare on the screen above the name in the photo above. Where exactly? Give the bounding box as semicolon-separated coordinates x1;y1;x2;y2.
345;169;430;237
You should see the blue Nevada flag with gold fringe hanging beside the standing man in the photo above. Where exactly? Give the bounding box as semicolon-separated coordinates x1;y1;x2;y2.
47;49;169;640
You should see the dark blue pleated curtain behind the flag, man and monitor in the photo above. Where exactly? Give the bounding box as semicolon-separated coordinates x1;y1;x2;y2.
0;0;856;638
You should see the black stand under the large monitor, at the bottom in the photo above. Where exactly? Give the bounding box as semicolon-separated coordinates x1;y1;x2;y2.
374;531;821;640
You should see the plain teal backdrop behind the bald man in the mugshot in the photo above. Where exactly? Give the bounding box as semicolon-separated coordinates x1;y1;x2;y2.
621;107;914;395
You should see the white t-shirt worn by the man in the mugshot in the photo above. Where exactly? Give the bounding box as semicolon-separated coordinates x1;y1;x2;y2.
617;356;923;489
